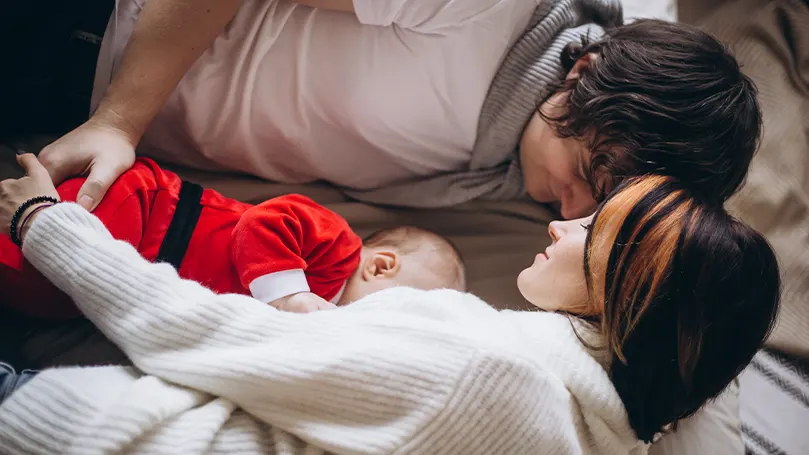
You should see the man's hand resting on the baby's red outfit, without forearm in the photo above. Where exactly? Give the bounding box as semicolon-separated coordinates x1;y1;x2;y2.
38;120;135;214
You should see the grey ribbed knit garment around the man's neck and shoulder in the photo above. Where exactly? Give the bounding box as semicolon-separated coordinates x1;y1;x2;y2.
347;0;623;207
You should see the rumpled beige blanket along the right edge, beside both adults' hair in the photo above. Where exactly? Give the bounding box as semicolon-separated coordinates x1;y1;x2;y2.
688;0;809;357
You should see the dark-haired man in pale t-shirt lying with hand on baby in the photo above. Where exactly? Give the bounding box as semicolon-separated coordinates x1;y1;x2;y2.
0;0;761;218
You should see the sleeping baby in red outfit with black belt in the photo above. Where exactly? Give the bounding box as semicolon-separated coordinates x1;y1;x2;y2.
0;159;466;318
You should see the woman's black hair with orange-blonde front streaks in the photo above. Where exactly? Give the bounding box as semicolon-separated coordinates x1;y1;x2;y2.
584;176;781;442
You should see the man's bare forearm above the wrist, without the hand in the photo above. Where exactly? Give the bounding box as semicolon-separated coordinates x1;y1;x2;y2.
93;0;243;144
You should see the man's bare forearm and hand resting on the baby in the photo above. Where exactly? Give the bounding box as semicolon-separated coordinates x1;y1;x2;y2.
39;0;241;210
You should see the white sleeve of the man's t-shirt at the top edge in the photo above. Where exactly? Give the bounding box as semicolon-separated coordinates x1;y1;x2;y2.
354;0;504;31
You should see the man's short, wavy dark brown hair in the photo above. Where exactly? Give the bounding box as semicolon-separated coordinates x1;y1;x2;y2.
540;20;761;202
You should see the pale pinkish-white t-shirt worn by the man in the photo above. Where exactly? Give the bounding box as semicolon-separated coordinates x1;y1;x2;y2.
94;0;541;189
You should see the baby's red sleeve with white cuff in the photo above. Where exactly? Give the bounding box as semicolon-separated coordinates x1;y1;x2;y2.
231;195;362;301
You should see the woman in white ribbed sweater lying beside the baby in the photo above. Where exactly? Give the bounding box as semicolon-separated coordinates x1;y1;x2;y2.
0;155;780;454
